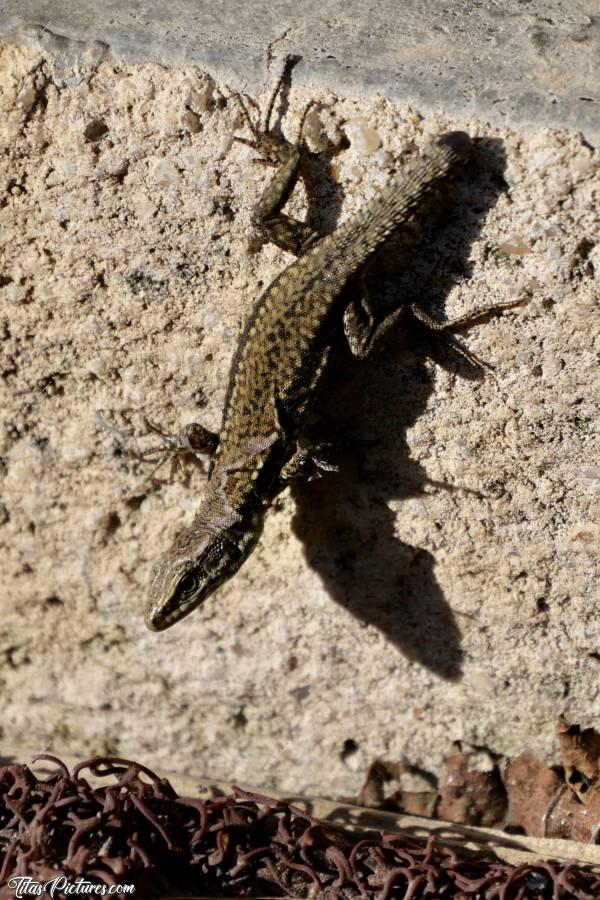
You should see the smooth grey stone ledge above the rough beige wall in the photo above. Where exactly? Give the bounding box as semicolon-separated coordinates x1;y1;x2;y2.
0;0;600;143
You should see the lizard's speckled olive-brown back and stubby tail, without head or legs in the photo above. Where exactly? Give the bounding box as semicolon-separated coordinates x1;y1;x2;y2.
210;133;470;502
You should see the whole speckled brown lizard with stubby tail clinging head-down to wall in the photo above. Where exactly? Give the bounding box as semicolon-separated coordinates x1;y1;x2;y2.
145;58;522;631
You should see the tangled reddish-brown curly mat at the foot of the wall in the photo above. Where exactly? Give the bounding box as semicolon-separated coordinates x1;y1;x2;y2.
0;755;600;900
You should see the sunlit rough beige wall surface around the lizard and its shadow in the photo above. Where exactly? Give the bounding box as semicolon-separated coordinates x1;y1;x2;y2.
0;45;600;795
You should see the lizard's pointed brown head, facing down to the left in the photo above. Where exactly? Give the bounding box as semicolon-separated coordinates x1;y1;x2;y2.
145;512;264;631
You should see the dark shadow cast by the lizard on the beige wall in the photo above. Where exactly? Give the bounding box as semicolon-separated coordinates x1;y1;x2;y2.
292;139;505;680
